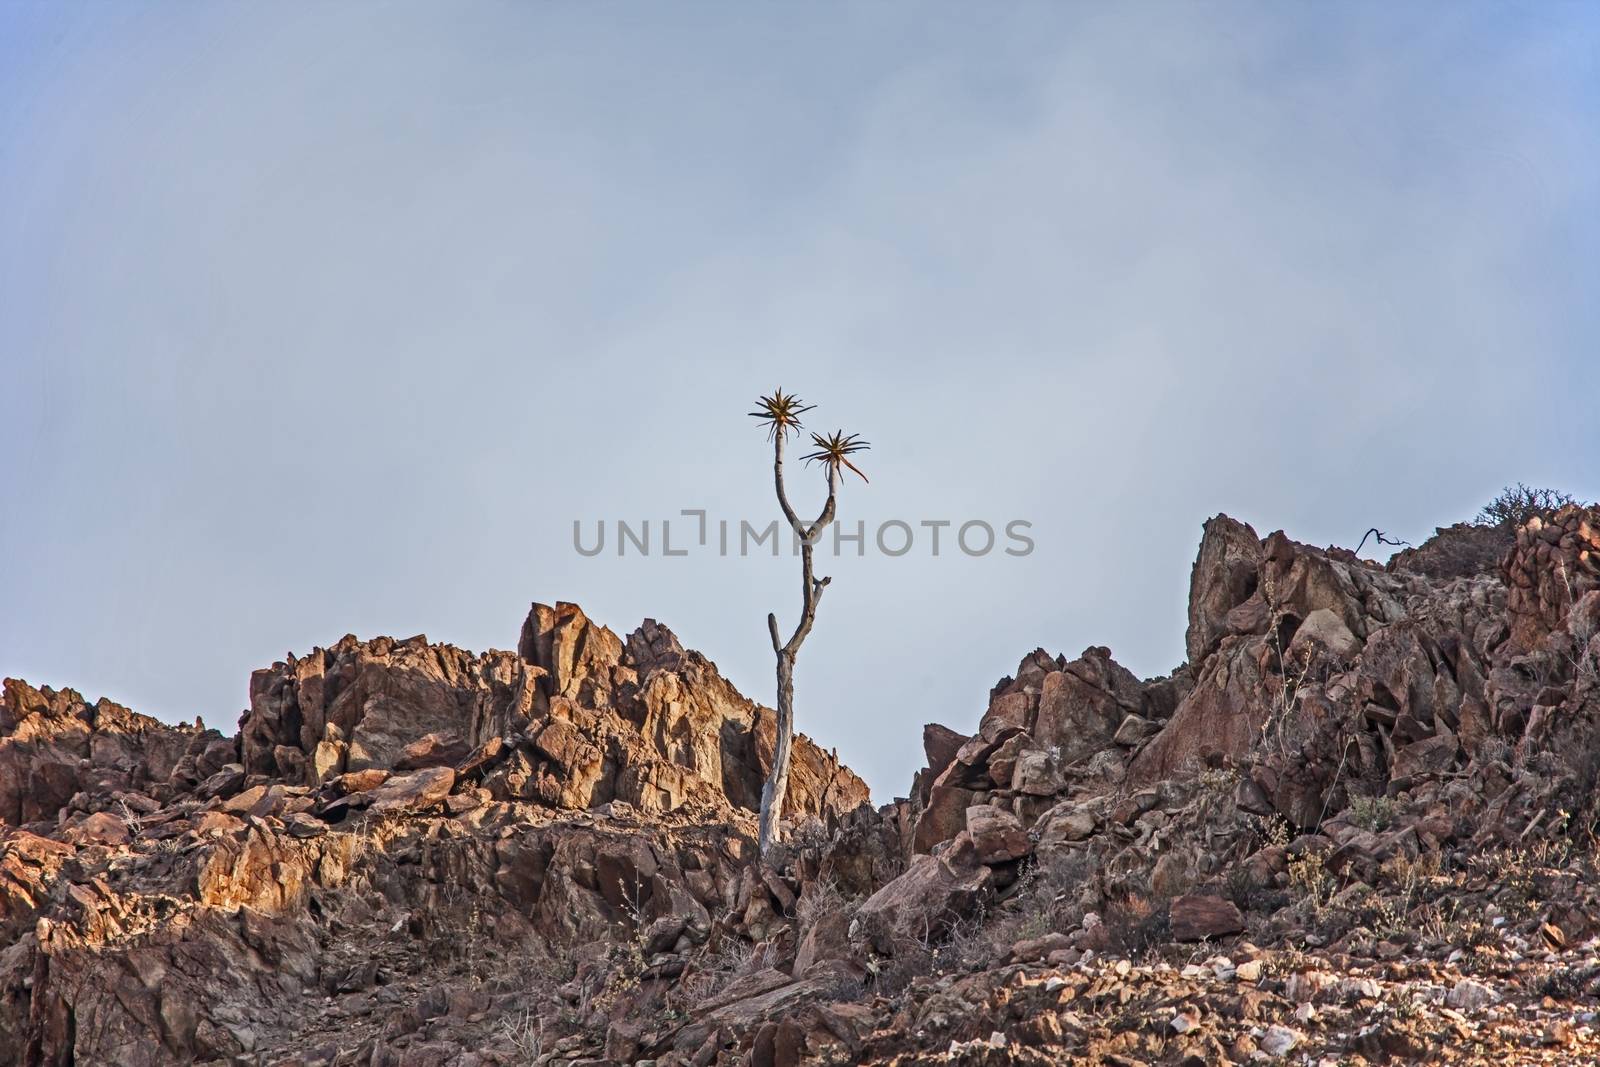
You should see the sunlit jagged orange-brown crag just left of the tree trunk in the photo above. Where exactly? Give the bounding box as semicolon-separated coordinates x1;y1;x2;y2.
240;605;867;817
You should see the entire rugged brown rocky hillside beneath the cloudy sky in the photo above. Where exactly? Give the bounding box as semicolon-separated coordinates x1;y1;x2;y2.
0;507;1600;1067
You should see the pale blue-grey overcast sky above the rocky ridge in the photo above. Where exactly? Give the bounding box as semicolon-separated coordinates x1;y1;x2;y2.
0;0;1600;801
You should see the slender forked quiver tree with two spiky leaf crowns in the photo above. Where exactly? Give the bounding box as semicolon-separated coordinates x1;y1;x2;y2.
750;389;867;856
